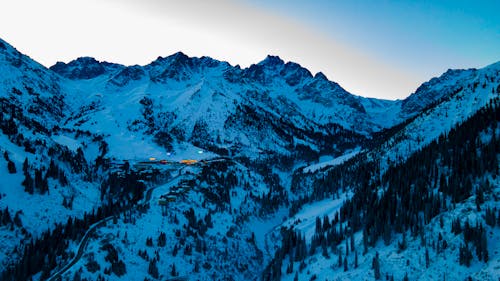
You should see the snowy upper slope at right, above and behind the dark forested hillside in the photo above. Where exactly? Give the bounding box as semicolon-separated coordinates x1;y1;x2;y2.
374;63;500;173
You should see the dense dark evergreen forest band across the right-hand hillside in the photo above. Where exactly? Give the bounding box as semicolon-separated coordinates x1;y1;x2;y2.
263;98;500;280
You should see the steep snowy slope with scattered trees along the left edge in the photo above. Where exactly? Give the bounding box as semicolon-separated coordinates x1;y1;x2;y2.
0;40;105;266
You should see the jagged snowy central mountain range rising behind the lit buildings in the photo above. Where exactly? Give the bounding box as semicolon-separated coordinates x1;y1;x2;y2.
51;53;401;161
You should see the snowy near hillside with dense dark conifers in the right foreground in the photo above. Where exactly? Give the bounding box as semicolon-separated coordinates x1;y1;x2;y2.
274;100;500;280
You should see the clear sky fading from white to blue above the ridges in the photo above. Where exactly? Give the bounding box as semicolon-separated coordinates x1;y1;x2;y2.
0;0;500;99
